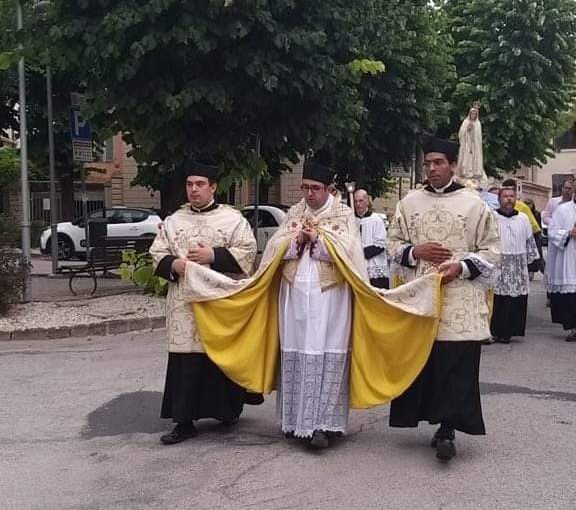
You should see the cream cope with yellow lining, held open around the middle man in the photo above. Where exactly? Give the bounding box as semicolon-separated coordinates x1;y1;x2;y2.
183;197;440;408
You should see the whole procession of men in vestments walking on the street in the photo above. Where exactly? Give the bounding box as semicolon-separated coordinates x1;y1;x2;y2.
151;138;576;462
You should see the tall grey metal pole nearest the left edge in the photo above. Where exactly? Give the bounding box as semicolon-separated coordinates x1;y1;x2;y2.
16;1;31;303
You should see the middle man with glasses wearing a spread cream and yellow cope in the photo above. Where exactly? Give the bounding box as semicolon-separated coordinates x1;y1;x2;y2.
183;161;440;448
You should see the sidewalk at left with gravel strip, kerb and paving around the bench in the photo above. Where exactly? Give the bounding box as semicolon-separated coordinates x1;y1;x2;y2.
0;252;165;341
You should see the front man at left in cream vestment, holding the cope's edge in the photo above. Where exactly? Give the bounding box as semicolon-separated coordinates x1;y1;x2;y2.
150;161;256;444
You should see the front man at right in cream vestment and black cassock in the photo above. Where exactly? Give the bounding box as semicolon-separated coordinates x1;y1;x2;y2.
388;138;500;461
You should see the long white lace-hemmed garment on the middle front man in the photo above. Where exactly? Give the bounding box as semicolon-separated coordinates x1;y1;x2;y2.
278;197;352;437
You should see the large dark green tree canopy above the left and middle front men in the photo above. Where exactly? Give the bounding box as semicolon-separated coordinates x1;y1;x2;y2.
45;0;394;210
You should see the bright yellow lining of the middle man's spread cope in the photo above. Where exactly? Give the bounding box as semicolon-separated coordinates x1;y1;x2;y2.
193;237;441;408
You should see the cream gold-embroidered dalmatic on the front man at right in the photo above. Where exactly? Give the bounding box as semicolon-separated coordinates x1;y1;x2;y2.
388;188;500;341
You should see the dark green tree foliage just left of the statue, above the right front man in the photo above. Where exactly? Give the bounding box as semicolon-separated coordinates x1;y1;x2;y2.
328;0;455;193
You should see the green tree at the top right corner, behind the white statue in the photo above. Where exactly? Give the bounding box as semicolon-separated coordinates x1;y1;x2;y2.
444;0;576;172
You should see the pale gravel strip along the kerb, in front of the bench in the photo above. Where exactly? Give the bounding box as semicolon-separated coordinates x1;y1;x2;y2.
0;294;165;332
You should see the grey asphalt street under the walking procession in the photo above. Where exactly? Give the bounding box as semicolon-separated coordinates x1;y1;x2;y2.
0;282;576;510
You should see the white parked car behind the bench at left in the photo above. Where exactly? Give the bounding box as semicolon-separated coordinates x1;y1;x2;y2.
40;206;162;260
